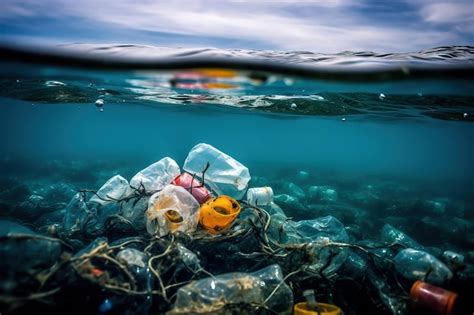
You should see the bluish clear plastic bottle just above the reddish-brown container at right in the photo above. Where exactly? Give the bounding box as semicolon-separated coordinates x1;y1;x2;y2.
393;248;453;285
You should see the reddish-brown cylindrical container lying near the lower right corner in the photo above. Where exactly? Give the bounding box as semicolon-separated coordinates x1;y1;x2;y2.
410;280;458;315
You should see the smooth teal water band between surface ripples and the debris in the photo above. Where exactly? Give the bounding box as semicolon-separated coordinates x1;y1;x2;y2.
0;95;474;191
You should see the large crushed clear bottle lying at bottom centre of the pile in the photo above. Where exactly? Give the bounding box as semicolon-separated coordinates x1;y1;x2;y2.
167;265;293;315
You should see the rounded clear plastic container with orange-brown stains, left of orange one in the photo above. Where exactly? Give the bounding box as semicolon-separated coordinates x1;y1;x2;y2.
145;185;199;236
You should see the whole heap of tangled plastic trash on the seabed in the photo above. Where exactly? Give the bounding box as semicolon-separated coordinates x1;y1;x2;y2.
0;144;473;315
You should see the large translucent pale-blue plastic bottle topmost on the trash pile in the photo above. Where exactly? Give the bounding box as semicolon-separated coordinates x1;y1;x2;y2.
183;143;250;199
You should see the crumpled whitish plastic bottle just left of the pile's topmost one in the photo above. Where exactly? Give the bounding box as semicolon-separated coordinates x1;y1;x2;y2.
130;157;181;192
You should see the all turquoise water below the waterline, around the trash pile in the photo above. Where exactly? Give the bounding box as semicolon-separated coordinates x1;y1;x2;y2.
0;45;474;314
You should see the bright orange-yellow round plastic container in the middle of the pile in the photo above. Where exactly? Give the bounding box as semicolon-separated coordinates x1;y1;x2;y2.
199;195;240;234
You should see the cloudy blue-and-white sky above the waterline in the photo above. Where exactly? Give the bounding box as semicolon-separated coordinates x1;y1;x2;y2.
0;0;474;53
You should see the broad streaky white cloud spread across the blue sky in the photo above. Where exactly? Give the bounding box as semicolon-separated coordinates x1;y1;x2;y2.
0;0;472;52
